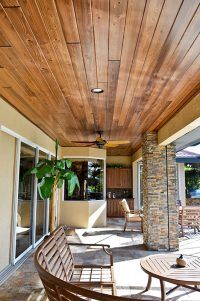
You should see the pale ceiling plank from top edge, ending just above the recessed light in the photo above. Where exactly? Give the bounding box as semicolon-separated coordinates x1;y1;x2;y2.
92;0;109;82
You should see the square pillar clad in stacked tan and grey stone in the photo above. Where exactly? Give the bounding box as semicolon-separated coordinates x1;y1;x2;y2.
142;132;178;250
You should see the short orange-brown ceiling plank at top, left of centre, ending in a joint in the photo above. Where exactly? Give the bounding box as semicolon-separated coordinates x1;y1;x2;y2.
55;0;80;43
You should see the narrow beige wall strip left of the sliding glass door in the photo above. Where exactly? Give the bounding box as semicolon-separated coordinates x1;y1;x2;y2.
0;132;15;271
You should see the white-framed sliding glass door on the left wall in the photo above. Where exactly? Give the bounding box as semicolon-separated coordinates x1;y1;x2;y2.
12;140;49;263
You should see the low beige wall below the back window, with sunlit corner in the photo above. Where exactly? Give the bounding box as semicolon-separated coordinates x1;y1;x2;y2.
59;200;106;228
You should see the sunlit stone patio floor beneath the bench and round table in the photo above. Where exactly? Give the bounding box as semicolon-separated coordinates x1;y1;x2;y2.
0;219;200;301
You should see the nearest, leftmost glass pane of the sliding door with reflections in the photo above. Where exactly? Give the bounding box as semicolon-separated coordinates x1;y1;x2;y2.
16;143;35;258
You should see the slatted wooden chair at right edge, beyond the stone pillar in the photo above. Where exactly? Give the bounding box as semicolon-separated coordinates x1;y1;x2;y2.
179;206;200;236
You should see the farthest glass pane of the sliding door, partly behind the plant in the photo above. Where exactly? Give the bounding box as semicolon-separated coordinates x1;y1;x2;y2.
35;151;47;242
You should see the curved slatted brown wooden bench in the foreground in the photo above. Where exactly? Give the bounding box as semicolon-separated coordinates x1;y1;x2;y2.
34;227;149;301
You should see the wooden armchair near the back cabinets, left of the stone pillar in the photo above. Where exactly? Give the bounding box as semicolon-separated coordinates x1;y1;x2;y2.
120;199;143;232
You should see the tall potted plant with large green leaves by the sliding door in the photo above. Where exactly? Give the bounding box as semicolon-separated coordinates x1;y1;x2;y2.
25;139;79;231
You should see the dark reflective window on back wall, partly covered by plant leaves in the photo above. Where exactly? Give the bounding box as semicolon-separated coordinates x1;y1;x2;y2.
65;159;104;200
